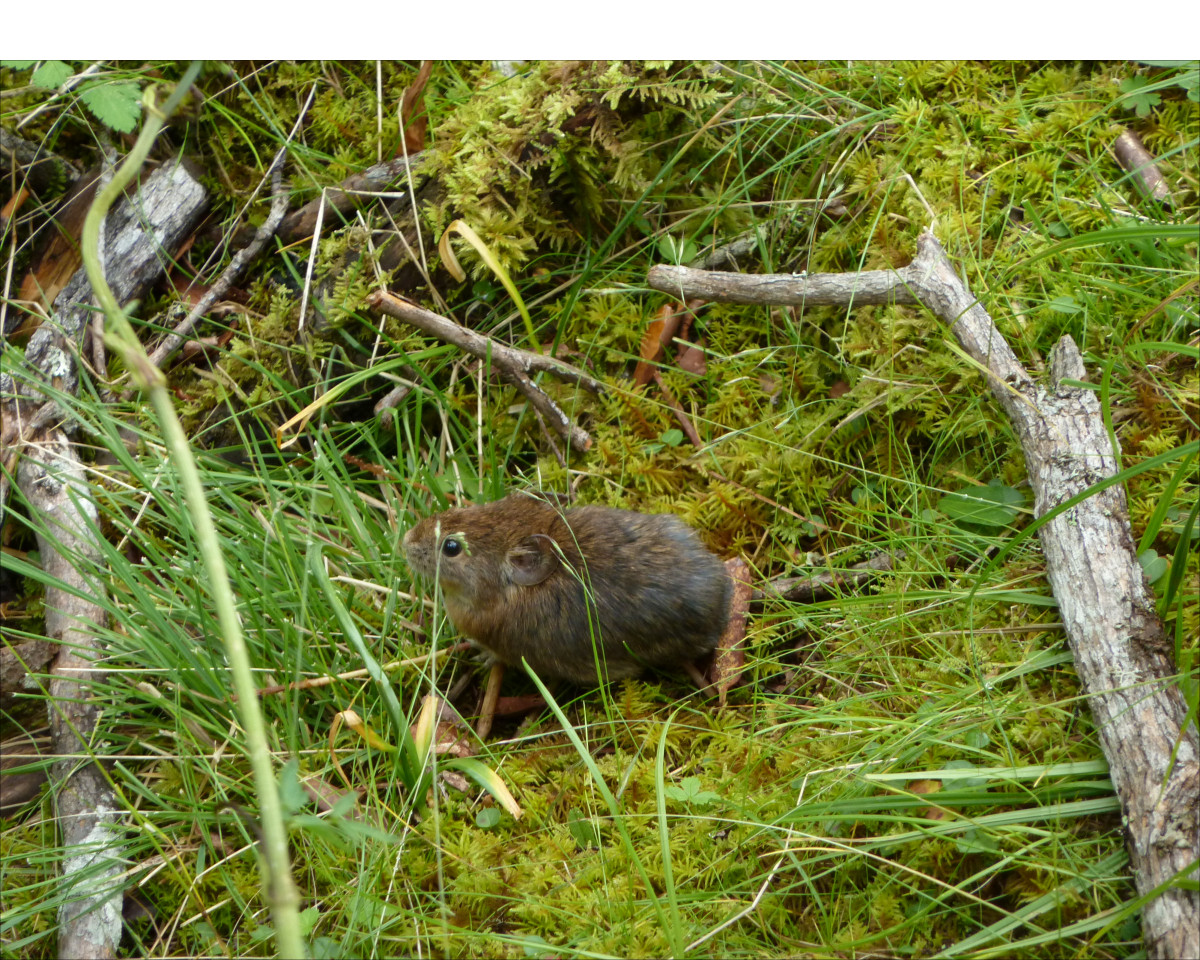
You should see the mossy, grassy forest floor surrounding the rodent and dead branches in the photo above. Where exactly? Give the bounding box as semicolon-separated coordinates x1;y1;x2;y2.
0;61;1200;959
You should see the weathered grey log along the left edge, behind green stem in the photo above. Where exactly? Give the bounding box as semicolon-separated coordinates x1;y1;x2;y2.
0;156;208;958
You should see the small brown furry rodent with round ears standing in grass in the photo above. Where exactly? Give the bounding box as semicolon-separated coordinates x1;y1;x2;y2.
404;493;733;684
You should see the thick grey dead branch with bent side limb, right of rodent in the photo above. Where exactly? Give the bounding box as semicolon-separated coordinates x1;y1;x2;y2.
649;233;1200;958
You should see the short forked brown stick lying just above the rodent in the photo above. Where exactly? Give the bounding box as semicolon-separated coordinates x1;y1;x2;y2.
366;290;604;454
